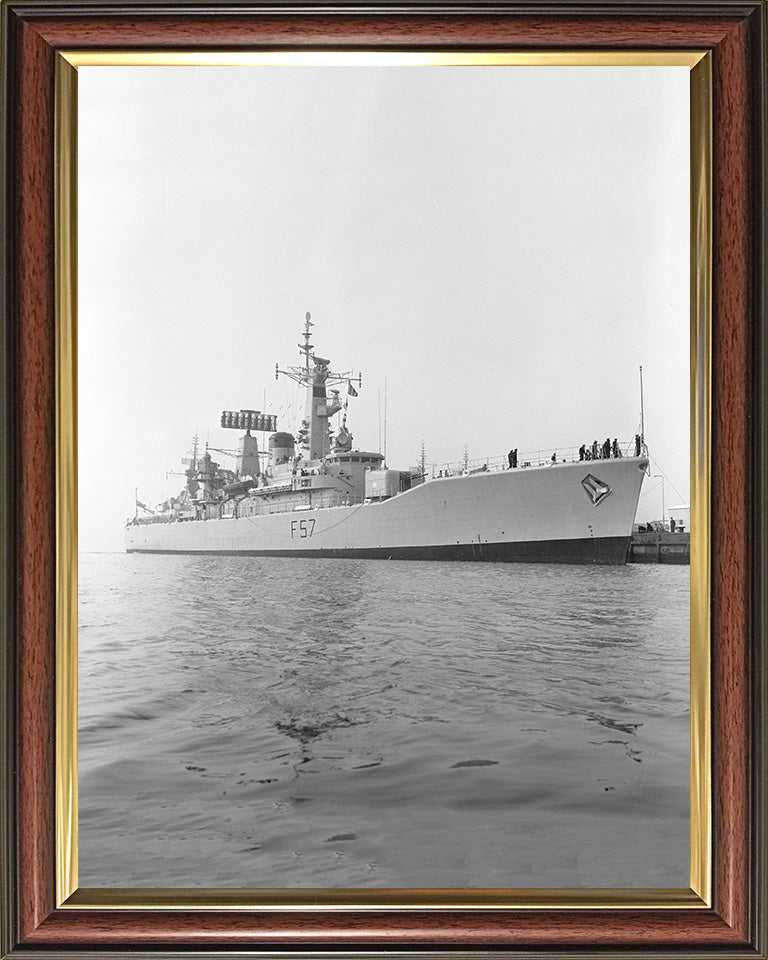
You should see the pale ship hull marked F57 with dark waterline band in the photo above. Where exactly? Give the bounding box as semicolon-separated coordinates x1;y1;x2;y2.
126;457;648;564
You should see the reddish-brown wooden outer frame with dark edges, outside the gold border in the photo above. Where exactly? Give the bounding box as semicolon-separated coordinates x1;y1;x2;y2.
0;0;768;958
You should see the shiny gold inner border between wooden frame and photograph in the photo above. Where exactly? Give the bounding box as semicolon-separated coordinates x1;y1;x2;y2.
54;50;713;912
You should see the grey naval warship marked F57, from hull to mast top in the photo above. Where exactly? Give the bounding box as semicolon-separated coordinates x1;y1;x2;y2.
125;314;648;564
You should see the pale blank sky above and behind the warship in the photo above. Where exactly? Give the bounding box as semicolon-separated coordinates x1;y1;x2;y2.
78;66;689;550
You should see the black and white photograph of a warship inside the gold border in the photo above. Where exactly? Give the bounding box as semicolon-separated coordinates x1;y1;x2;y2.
77;54;691;890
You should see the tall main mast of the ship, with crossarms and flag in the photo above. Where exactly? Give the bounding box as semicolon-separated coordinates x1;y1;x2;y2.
275;313;362;461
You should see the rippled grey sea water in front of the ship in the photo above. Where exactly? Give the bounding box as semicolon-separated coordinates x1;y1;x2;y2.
79;554;689;887
